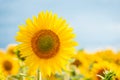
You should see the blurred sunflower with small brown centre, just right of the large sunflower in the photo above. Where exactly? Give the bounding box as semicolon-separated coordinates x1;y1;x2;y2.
72;50;90;78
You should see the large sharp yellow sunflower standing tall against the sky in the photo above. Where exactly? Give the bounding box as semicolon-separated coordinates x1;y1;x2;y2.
16;12;76;76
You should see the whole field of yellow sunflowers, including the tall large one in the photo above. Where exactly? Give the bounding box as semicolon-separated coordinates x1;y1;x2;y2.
0;11;120;80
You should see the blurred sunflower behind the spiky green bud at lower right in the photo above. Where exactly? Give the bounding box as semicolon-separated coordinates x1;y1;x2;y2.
92;62;116;80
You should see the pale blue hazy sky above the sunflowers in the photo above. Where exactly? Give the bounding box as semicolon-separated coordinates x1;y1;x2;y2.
0;0;120;50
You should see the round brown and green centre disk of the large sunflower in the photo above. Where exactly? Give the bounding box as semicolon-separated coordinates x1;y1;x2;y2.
31;30;60;58
